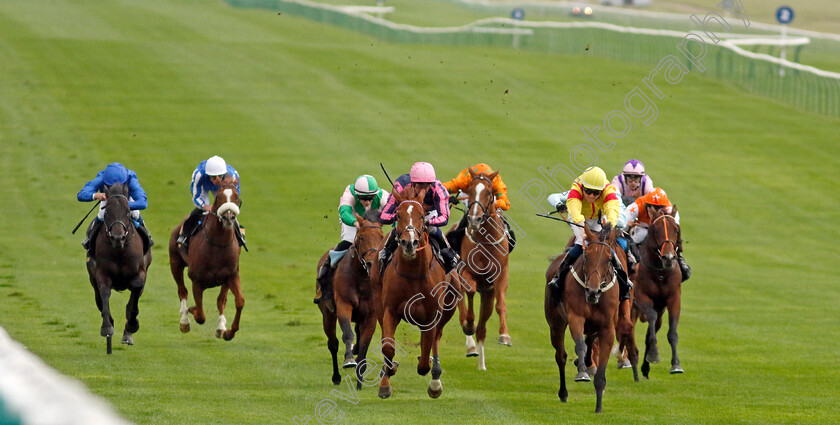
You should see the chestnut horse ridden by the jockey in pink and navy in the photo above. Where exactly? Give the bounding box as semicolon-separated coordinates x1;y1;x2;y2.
378;187;461;398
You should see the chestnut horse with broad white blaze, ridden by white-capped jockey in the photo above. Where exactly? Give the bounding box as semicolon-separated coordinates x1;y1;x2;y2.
169;176;245;341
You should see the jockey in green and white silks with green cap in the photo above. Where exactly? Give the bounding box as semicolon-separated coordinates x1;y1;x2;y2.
315;174;390;304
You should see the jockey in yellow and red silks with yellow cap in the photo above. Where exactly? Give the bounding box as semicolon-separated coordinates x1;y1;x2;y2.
548;167;632;300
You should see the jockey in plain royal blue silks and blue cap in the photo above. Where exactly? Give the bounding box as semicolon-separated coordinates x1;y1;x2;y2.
76;162;154;251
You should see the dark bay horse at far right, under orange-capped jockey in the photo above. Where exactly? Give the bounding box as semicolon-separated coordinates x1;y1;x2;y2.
633;205;685;378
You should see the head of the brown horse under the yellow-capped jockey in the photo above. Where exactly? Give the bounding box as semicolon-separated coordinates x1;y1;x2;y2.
575;223;616;304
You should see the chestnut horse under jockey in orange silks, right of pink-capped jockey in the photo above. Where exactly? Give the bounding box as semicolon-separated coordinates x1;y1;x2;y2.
456;168;511;370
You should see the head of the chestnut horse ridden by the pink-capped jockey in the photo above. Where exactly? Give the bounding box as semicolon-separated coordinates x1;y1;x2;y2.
394;186;429;259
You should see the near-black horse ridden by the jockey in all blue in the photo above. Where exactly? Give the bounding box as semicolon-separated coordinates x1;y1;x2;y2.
87;183;152;354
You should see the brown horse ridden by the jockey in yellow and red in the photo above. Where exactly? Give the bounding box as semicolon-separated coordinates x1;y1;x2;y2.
545;224;619;413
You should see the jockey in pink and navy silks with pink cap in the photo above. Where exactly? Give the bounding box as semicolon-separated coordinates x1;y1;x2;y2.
379;162;458;273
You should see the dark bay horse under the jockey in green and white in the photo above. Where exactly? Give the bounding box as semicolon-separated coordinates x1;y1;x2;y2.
318;210;385;389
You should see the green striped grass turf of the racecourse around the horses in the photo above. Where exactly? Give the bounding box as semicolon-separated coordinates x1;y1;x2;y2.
0;0;840;424
